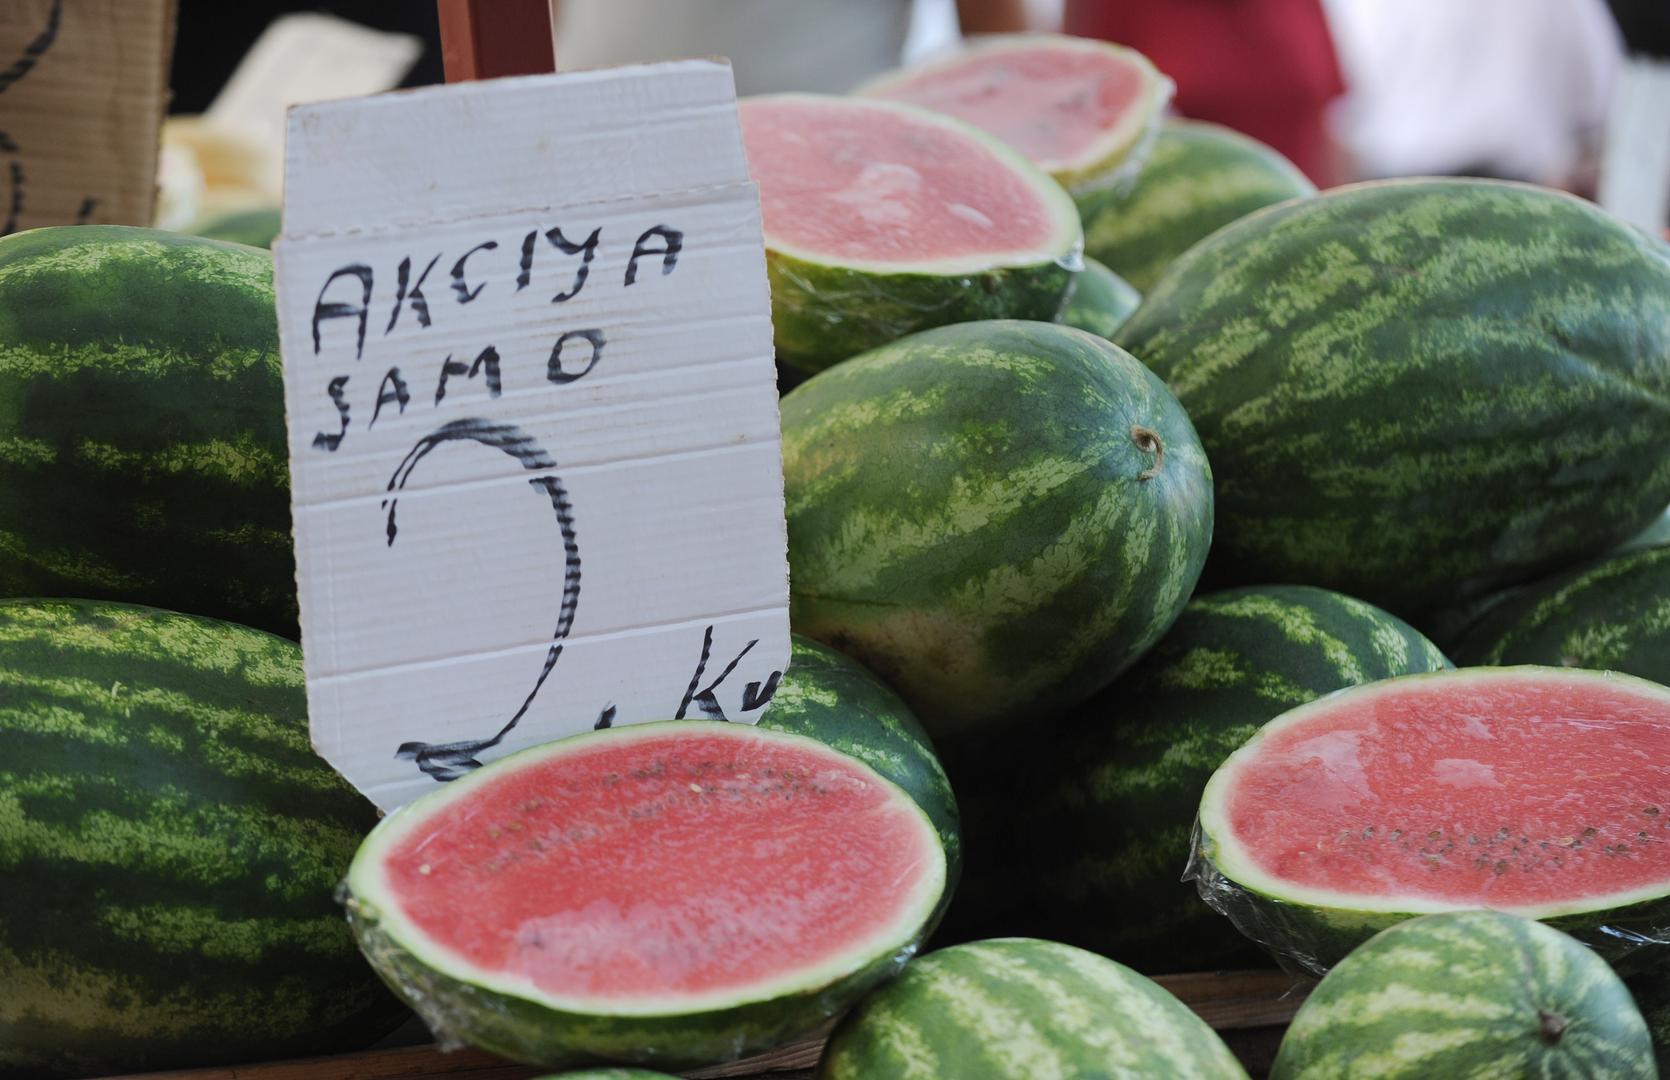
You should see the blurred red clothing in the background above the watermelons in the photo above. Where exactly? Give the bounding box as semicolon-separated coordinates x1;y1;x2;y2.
1065;0;1344;184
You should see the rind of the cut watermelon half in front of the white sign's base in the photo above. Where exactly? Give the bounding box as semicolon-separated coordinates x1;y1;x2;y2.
344;721;945;1068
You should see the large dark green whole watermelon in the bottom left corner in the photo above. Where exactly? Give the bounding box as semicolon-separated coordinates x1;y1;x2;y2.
0;599;407;1077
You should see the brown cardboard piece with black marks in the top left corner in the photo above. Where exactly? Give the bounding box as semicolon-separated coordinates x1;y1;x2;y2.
0;0;174;234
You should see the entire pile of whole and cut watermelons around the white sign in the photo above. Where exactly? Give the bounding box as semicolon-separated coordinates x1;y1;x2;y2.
0;35;1670;1080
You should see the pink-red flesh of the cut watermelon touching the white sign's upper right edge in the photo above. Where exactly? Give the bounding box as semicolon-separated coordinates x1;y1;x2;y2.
741;93;1075;272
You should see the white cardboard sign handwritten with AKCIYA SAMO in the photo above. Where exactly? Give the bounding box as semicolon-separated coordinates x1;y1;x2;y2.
276;62;788;808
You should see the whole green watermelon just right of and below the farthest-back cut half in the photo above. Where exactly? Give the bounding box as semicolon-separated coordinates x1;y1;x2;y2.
1079;120;1316;292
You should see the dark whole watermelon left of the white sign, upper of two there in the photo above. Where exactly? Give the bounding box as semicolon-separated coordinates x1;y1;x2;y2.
0;225;297;638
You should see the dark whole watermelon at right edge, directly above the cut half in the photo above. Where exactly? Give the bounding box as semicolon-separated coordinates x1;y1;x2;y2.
1455;548;1670;683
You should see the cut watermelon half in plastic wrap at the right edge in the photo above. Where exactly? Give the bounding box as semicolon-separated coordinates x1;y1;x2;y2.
1192;668;1670;971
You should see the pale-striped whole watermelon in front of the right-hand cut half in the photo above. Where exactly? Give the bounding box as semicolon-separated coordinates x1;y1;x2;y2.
1271;911;1658;1080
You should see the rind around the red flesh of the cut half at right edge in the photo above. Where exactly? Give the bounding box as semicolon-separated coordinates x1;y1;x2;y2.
1187;666;1670;975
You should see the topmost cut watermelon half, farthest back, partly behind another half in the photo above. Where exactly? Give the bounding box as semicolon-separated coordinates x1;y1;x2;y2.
858;33;1174;195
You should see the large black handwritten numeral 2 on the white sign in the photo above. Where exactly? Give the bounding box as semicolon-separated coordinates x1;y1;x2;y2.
382;417;587;781
